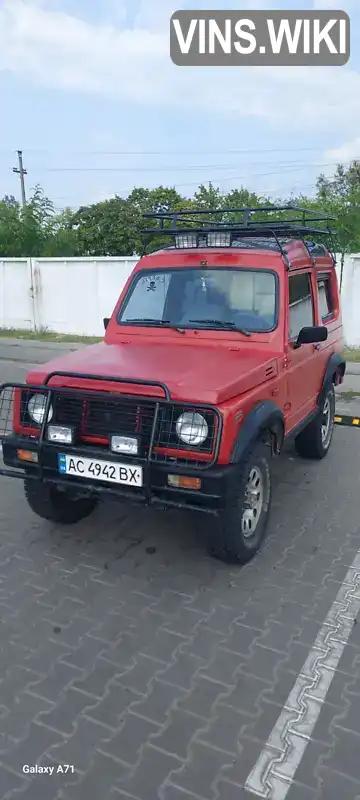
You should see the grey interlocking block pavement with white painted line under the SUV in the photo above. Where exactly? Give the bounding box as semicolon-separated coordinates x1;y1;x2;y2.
0;345;360;800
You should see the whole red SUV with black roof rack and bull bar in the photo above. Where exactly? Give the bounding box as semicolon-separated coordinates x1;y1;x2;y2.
0;206;345;563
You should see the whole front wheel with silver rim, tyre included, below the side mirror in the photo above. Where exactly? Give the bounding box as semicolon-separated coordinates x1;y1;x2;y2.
209;441;272;564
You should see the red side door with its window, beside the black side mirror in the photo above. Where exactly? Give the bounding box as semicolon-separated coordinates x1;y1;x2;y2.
285;270;320;431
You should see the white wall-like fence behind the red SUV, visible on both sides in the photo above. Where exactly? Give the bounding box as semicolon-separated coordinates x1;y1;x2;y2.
0;253;360;347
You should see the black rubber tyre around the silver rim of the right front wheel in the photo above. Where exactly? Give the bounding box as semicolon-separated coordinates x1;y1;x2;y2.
209;441;272;564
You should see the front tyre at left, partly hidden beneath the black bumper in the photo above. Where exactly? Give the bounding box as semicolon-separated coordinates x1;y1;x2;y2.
24;478;97;525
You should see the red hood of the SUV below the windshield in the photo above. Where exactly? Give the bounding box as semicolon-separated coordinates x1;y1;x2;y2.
26;342;277;405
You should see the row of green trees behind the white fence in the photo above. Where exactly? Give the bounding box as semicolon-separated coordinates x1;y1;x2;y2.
0;166;360;258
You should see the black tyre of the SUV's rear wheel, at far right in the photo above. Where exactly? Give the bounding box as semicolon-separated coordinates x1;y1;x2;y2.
295;383;335;459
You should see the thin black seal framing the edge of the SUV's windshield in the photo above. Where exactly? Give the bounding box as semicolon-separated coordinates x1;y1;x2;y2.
115;265;280;335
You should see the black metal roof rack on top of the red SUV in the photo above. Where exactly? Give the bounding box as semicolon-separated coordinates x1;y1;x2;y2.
142;204;336;259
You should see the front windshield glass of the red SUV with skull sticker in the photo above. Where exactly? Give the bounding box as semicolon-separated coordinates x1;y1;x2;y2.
118;267;277;333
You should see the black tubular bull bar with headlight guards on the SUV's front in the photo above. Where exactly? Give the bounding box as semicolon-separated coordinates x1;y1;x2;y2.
0;372;233;515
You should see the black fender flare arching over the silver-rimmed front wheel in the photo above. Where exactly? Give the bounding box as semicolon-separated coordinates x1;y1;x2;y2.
230;400;285;464
